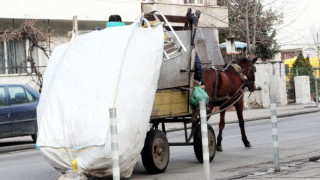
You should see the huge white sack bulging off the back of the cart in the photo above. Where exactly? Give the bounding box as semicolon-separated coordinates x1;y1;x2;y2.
37;20;164;177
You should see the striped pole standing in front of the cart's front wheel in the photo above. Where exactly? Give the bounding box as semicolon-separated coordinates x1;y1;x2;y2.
199;100;210;180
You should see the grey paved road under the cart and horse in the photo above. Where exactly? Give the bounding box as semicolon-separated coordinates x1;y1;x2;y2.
0;113;320;180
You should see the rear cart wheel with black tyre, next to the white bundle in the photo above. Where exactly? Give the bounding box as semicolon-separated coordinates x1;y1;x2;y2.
141;130;170;174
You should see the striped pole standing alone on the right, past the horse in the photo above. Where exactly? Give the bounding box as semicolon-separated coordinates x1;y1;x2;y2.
270;96;280;172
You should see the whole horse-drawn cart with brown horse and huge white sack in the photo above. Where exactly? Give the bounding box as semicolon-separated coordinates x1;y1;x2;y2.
37;8;257;178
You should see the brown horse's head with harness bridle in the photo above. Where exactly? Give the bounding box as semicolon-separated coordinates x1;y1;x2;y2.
237;57;258;92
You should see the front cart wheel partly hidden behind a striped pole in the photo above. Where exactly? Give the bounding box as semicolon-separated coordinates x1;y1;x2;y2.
193;124;217;163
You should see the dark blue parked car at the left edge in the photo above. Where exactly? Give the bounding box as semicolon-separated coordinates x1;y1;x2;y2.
0;84;40;142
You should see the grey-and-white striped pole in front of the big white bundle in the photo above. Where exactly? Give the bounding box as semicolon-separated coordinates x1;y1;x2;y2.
109;108;120;180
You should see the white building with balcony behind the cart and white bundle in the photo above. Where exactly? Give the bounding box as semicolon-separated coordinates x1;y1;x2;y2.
0;0;228;88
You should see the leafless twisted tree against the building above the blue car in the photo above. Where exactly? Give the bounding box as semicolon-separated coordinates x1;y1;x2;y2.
0;20;53;92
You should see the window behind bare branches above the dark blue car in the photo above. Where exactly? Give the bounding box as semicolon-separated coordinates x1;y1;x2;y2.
0;40;39;74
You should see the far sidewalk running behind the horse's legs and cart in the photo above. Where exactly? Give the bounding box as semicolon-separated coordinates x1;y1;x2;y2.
166;103;320;132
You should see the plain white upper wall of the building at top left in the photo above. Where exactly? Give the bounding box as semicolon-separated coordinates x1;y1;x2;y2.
0;0;141;22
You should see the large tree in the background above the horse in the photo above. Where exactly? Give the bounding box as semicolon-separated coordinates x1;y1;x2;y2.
218;0;283;59
